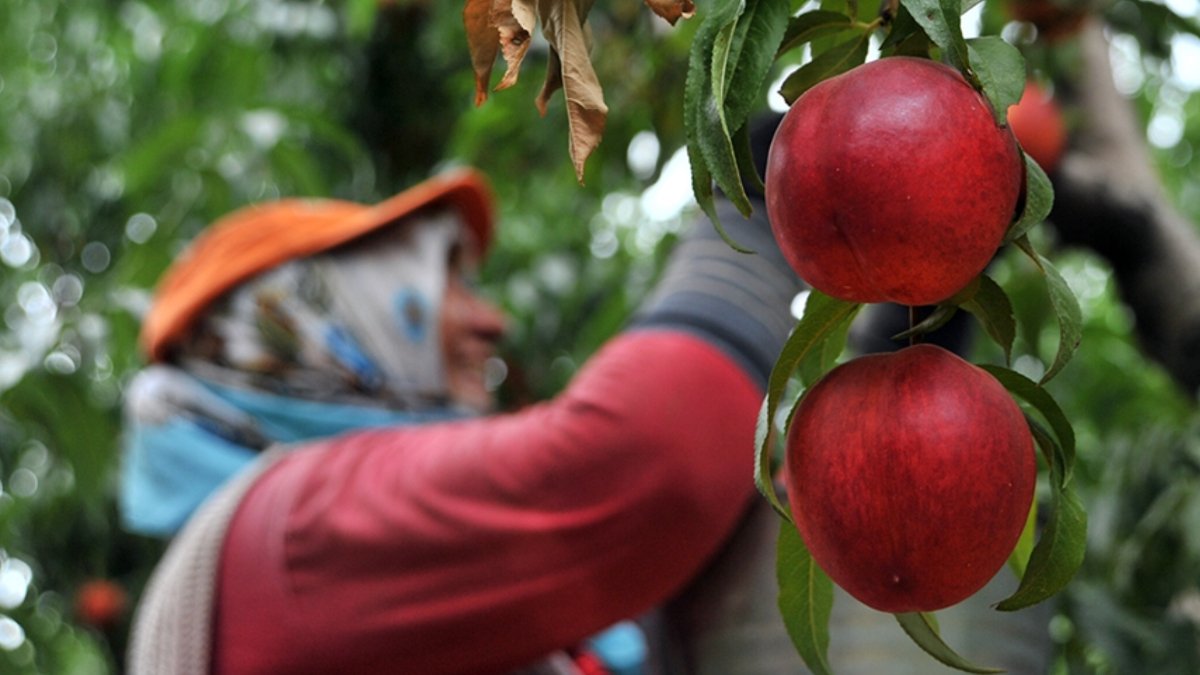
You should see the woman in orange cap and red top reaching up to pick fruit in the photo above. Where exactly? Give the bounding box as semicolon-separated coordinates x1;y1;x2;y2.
124;164;799;675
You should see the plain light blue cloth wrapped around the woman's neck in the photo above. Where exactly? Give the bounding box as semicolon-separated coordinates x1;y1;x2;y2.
120;372;464;537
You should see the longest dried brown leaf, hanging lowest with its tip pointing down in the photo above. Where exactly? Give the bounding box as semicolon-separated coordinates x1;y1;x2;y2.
538;0;608;183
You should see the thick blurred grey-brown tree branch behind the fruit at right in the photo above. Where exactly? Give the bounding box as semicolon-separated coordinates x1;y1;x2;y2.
1050;19;1200;395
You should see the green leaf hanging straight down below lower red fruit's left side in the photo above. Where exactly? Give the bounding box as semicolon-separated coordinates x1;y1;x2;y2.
775;521;833;675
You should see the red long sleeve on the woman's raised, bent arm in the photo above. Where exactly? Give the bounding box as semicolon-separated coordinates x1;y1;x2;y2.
215;328;761;674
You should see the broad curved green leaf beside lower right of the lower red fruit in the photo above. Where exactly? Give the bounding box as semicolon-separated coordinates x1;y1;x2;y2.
996;446;1087;611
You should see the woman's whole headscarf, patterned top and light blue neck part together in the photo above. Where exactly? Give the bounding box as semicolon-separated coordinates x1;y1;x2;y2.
121;211;470;536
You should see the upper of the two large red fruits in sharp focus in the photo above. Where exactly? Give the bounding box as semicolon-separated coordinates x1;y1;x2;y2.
766;56;1025;305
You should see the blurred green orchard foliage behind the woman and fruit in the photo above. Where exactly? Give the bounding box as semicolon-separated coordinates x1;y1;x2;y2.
0;0;1200;675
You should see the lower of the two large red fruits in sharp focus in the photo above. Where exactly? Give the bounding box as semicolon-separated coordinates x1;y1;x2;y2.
786;345;1037;613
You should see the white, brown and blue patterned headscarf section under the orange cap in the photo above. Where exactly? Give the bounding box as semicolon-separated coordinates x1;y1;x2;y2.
169;211;462;411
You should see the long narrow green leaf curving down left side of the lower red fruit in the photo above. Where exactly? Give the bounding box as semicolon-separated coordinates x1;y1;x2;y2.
755;291;862;522
